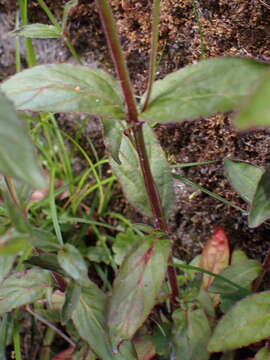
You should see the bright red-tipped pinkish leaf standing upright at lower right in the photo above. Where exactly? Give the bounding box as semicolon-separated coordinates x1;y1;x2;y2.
200;226;230;289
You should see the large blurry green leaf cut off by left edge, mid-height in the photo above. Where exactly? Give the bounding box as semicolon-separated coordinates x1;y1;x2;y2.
0;91;45;188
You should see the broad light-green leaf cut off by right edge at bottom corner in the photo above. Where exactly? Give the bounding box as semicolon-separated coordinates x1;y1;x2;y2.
208;291;270;352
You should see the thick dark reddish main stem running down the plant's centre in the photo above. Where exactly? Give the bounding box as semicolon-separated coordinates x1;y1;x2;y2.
95;0;179;304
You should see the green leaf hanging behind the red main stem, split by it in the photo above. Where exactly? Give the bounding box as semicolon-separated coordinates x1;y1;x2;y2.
110;124;174;216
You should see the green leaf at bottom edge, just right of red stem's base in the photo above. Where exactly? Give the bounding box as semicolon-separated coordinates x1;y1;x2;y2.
172;309;211;360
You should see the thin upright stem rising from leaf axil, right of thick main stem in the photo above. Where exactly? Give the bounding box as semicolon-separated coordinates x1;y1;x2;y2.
142;0;160;112
